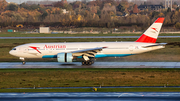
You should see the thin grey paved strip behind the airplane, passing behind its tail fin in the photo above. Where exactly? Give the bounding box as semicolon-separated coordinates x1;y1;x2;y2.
0;36;180;39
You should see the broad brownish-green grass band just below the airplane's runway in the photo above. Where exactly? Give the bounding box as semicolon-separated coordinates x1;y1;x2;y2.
0;68;180;88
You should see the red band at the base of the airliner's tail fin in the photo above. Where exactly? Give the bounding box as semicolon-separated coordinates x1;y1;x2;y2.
136;34;157;43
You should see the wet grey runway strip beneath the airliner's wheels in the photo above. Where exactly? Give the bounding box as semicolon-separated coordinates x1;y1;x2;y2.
0;62;180;69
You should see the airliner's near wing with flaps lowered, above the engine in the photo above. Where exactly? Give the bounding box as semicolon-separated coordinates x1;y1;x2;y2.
71;47;107;57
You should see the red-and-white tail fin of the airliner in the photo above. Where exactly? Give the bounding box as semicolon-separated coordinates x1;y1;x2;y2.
136;17;164;43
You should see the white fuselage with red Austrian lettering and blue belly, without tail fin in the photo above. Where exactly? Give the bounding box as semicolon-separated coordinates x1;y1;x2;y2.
10;42;164;58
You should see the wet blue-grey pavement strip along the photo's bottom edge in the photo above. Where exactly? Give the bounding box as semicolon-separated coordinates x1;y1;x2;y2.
0;92;180;101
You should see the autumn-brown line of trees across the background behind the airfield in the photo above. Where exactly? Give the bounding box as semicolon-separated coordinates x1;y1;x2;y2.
0;0;180;29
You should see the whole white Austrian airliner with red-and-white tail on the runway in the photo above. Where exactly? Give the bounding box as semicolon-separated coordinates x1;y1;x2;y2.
9;17;166;65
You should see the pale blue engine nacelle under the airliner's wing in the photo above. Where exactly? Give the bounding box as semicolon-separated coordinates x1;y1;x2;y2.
57;53;73;63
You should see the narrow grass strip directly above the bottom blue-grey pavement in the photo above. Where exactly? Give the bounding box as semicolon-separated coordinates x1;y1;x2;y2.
0;88;180;94
